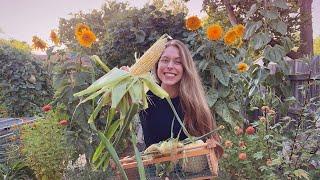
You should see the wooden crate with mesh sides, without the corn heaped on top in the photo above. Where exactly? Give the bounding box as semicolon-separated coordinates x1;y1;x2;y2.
116;139;223;180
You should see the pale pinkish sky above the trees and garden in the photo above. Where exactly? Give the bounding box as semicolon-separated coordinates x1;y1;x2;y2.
0;0;320;44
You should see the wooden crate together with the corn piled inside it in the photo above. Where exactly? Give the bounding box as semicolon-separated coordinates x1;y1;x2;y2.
115;139;223;180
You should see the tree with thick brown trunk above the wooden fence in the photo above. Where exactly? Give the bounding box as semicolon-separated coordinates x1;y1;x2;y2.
203;0;313;59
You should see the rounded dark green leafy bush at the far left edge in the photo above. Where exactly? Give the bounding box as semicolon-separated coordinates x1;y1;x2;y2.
0;44;53;117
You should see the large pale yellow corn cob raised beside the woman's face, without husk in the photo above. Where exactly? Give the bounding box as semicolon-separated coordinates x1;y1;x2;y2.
130;34;170;76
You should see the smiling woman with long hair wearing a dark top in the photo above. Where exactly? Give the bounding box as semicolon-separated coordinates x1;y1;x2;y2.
139;40;216;147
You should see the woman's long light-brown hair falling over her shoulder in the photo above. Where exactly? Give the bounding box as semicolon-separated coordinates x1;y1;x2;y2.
155;40;216;136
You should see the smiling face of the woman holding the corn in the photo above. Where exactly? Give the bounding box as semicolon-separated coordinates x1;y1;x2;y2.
157;46;183;92
